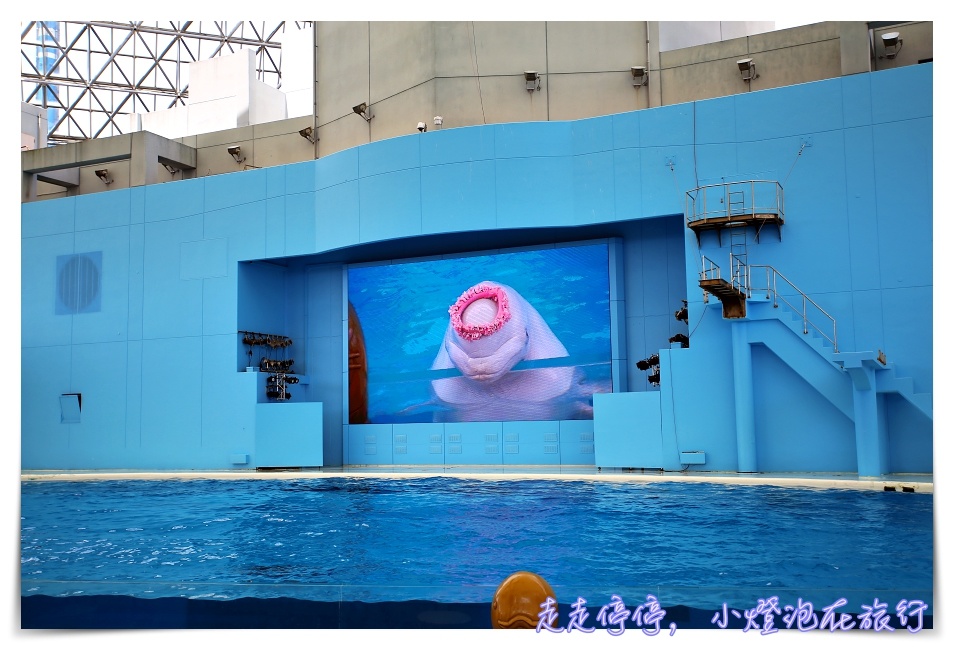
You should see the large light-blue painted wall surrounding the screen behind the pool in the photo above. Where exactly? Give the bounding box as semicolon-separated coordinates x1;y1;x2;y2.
21;64;933;472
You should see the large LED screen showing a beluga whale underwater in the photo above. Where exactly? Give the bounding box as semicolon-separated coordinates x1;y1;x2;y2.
348;243;612;424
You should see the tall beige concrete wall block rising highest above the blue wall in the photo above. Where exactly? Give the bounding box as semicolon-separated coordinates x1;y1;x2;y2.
316;21;648;156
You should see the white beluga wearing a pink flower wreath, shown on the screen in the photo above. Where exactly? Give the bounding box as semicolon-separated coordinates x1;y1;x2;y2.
431;281;580;422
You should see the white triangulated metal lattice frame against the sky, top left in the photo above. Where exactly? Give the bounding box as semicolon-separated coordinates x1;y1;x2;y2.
20;20;310;144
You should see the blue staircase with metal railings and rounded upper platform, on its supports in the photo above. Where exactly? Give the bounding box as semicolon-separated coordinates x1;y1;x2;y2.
686;181;933;476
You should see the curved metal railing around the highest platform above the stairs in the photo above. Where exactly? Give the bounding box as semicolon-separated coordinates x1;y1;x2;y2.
686;180;785;224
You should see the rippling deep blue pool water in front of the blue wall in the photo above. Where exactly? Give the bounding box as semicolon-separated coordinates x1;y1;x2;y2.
20;477;934;627
